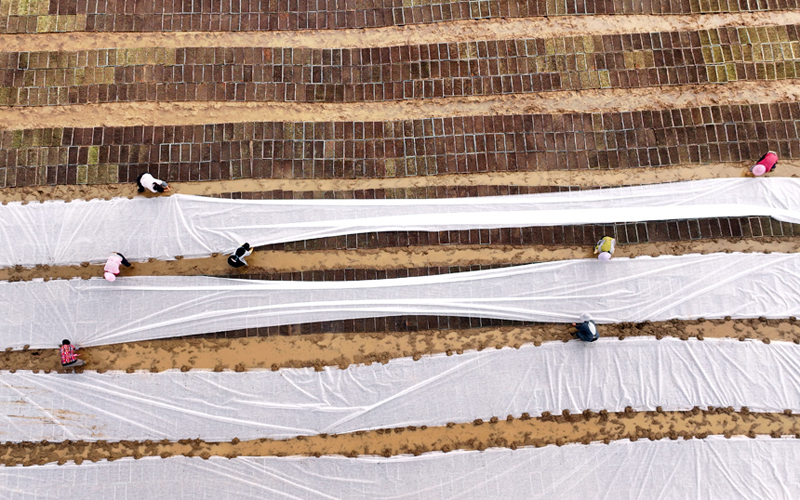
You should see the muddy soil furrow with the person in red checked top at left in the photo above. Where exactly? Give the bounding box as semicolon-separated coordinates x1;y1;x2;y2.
0;318;800;373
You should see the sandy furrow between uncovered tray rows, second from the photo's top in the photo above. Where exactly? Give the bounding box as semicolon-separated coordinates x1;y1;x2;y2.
0;80;800;130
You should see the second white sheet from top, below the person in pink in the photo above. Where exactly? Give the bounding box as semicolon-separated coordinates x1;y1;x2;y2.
0;253;800;349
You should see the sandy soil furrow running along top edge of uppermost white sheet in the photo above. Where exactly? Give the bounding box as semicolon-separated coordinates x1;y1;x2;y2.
0;164;800;203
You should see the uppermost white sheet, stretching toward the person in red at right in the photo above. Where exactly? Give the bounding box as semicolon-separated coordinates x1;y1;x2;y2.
0;178;800;267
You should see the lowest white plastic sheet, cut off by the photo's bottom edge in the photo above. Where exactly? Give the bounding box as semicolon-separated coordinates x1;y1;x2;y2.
0;436;800;500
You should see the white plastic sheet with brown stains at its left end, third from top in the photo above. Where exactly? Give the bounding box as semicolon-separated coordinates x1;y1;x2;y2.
0;338;800;442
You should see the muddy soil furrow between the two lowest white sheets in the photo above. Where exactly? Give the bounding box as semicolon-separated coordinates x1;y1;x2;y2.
0;407;800;466
